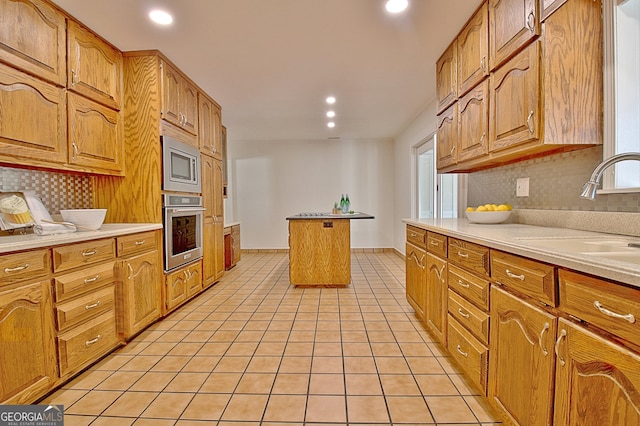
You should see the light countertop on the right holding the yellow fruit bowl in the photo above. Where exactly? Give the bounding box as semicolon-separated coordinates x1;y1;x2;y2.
402;219;640;287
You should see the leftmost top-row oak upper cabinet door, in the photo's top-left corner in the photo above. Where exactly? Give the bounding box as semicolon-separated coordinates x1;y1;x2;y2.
0;0;66;86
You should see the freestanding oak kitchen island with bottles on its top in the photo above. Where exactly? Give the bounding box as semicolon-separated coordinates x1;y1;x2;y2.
287;213;374;287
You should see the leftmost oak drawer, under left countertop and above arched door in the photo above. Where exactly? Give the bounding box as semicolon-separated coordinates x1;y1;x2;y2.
0;249;51;285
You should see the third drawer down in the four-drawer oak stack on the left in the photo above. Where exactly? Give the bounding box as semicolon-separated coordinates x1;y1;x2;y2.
56;285;115;331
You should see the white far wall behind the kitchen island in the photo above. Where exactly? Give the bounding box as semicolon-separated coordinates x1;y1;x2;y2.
225;136;395;249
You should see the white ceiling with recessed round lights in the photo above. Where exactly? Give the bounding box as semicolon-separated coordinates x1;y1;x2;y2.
54;0;481;140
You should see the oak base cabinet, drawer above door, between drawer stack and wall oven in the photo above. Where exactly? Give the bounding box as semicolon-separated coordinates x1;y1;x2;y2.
116;231;163;340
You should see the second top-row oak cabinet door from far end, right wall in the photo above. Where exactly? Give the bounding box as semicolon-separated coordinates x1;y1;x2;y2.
457;2;489;97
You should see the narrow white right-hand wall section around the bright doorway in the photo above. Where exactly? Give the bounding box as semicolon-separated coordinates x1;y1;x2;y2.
393;99;437;253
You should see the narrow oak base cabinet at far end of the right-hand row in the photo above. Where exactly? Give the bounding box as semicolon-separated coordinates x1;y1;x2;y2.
405;225;427;321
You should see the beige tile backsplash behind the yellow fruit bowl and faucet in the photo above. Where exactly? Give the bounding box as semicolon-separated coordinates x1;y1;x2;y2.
467;147;640;213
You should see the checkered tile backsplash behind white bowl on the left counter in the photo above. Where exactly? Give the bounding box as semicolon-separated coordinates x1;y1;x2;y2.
0;167;93;214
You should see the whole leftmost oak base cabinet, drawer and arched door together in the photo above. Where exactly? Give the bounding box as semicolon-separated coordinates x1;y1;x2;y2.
0;249;58;404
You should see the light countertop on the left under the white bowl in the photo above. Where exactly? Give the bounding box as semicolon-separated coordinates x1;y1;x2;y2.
0;223;162;254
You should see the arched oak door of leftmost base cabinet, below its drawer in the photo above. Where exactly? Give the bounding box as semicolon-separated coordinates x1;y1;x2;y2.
0;280;57;404
